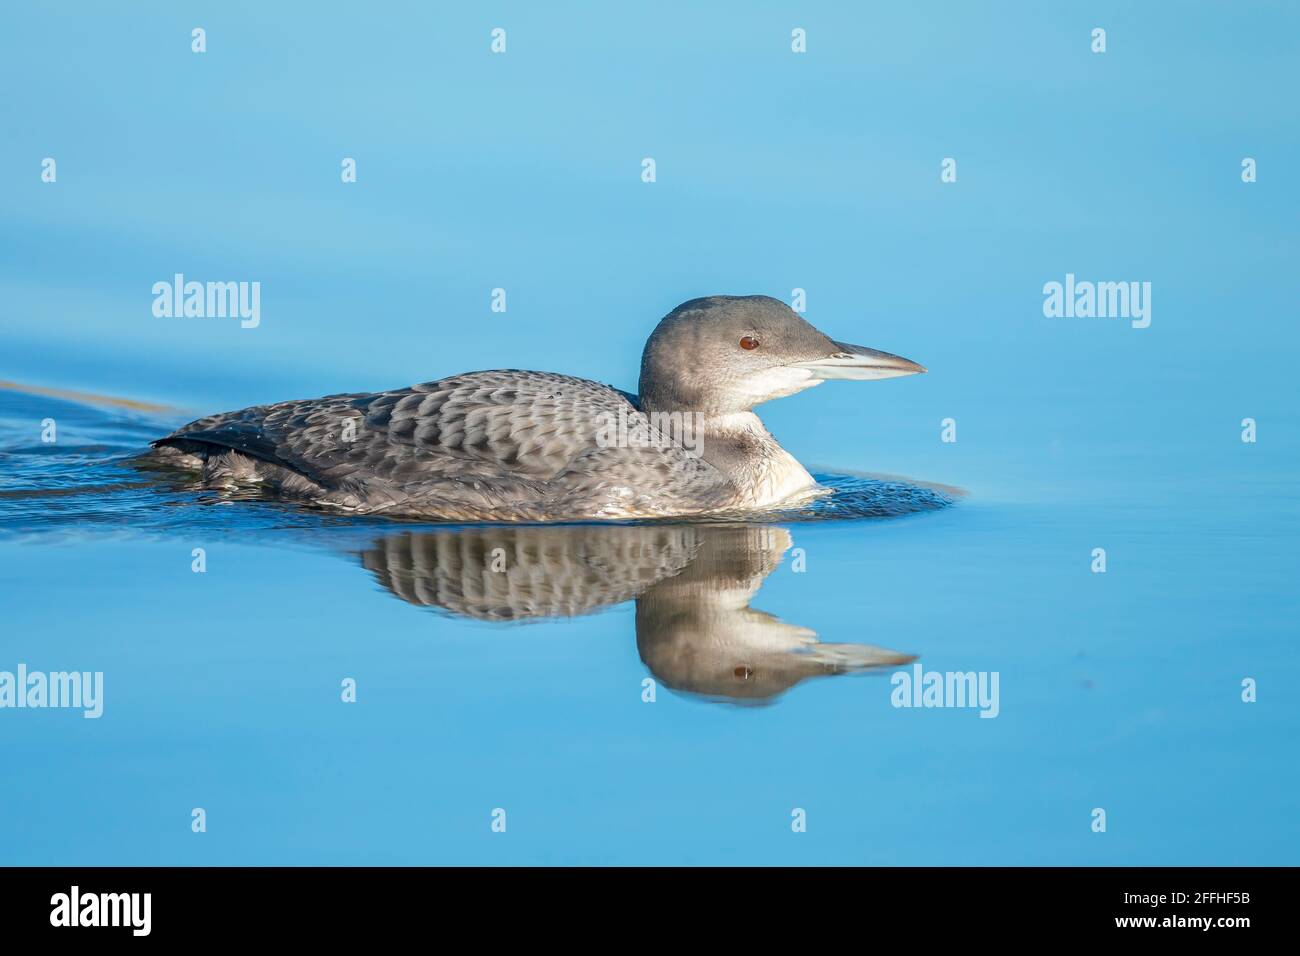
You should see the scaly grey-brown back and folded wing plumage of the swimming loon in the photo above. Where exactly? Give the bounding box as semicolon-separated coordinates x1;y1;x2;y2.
160;369;720;520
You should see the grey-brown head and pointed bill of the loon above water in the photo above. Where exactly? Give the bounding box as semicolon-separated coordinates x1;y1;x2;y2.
640;295;926;414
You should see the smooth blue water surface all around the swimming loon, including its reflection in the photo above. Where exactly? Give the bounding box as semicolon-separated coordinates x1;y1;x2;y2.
0;1;1300;865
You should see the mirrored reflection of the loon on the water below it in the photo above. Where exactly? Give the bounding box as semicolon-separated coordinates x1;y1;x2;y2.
361;524;914;702
